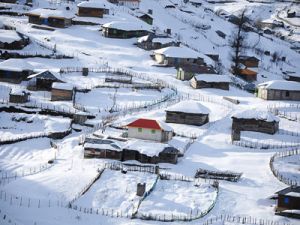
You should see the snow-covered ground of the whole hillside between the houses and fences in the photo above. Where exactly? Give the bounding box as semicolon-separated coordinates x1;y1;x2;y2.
0;0;300;225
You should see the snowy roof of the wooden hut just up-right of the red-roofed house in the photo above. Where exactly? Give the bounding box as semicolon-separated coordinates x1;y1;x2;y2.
166;100;209;114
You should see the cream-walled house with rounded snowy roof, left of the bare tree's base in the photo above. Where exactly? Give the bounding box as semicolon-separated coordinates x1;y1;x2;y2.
154;46;213;67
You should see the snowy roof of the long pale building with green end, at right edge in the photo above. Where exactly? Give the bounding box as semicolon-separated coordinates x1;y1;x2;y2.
257;80;300;91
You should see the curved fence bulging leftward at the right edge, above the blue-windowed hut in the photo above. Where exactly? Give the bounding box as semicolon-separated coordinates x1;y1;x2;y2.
269;149;300;186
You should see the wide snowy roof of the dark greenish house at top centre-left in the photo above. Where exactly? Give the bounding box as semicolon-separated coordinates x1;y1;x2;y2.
102;21;151;31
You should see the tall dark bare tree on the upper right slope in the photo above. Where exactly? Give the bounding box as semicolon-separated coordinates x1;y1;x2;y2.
229;9;247;75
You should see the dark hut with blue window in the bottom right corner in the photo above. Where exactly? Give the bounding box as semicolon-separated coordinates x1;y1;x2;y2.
276;186;300;218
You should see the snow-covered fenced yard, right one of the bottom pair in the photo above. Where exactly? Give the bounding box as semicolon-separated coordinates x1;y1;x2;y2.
138;180;217;221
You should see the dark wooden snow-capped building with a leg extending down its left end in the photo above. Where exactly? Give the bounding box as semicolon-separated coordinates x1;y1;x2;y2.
231;109;279;141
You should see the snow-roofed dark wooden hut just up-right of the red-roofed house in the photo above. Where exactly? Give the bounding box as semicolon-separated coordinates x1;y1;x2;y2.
166;100;209;126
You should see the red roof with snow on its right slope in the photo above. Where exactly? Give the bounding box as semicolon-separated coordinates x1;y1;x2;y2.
126;118;173;131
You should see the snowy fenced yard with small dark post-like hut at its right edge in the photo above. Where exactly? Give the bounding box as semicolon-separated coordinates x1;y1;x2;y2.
74;170;156;215
